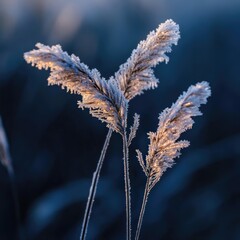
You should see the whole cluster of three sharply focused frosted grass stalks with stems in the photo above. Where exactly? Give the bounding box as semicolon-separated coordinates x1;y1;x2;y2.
2;20;211;240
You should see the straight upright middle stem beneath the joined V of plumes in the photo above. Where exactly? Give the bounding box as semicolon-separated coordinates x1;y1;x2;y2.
123;131;131;240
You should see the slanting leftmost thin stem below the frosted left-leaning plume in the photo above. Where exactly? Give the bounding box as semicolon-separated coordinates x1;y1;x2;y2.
80;129;112;240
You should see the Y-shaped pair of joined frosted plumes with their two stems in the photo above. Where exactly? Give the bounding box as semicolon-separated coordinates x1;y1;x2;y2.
24;20;180;239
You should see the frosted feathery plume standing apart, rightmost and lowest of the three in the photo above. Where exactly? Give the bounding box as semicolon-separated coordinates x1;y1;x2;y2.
137;82;211;191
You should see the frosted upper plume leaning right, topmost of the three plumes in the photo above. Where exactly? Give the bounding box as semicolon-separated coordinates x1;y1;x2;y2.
115;19;180;99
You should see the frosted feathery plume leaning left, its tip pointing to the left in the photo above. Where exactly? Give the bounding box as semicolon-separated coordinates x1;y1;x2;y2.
24;43;127;134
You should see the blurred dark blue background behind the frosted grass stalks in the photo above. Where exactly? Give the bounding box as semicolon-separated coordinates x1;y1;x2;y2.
0;0;240;240
